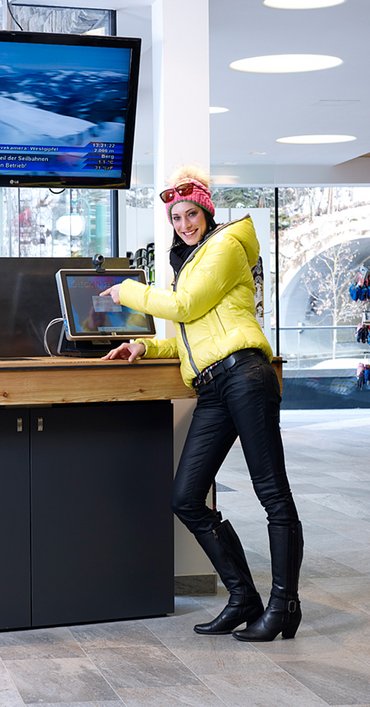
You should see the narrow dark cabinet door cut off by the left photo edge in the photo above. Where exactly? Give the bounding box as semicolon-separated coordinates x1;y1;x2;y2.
0;408;31;629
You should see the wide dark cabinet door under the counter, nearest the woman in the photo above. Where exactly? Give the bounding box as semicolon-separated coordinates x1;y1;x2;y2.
31;401;173;626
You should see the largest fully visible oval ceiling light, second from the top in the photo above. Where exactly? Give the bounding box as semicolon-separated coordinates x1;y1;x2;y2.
230;54;343;74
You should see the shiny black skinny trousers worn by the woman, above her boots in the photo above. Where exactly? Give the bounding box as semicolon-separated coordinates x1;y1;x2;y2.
173;352;298;535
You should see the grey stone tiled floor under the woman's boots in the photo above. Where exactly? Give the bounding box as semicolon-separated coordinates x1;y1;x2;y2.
0;410;370;707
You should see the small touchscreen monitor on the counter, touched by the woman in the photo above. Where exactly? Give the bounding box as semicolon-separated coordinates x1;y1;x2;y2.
55;269;155;344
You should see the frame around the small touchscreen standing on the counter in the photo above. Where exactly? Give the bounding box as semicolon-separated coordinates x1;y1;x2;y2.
55;268;156;344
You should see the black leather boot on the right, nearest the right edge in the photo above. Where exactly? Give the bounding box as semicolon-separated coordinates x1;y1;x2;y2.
233;523;303;642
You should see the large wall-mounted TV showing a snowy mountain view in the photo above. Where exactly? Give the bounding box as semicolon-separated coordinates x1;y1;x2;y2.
0;31;141;189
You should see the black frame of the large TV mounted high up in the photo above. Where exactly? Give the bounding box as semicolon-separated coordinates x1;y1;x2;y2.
0;30;141;189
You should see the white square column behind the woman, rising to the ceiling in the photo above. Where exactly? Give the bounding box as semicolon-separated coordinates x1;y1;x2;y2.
152;0;213;587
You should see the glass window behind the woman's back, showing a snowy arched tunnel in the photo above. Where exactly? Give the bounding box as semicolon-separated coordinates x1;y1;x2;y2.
279;186;370;370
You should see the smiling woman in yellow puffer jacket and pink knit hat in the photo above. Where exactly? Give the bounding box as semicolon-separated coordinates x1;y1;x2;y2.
102;168;303;641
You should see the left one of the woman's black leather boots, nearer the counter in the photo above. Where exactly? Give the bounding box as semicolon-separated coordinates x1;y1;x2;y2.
194;520;263;635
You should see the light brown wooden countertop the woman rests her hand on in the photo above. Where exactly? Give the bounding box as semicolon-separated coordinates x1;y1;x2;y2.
0;356;282;407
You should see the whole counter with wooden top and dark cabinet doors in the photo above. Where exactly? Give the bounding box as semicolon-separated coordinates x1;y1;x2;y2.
0;357;281;630
